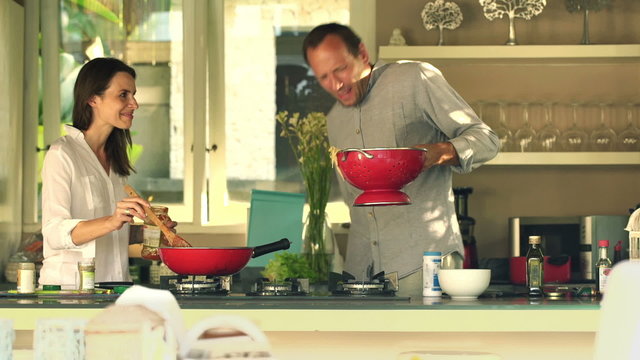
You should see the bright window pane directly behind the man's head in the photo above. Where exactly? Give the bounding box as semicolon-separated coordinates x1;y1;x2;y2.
225;0;349;201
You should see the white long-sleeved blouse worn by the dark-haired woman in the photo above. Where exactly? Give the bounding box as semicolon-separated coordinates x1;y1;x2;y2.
39;125;130;289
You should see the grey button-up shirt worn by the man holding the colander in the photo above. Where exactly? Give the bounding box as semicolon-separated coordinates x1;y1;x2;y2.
328;62;500;279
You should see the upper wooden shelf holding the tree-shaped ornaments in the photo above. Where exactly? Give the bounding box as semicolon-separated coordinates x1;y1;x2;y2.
378;44;640;62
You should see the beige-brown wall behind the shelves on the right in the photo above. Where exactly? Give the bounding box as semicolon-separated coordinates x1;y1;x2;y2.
376;0;640;257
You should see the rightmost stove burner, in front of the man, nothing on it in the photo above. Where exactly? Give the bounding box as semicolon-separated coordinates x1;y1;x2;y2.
329;271;398;297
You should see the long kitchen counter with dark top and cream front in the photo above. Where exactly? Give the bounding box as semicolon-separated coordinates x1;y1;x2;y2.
0;286;600;360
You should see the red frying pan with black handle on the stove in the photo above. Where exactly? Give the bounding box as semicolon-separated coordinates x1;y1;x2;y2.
159;239;291;276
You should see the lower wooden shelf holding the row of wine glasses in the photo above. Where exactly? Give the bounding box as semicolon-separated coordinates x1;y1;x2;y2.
487;152;640;165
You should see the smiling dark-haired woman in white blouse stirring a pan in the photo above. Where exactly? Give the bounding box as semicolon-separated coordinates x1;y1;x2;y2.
40;58;164;288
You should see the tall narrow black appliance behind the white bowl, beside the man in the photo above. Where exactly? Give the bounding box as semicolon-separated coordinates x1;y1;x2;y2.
453;187;478;269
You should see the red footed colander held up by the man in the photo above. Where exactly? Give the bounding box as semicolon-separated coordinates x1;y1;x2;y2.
335;148;427;206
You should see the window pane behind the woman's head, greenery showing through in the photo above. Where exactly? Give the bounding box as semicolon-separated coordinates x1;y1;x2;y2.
52;0;185;214
